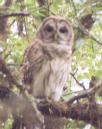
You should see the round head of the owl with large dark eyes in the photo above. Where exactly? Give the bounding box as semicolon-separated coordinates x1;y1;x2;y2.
37;16;73;45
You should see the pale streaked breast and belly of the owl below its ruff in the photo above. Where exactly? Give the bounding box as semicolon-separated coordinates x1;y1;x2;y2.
33;58;69;100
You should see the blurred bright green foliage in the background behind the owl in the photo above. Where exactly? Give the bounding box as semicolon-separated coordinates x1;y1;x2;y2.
0;0;102;129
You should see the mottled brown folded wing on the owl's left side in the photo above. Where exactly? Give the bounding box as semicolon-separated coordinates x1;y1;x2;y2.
22;40;44;84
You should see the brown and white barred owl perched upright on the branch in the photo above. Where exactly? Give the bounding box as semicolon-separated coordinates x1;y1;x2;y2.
22;16;73;101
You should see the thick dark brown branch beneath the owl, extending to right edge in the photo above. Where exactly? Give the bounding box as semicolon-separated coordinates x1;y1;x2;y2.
40;99;102;129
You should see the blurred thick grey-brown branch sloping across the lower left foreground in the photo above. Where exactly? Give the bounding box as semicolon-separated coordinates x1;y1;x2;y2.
0;86;44;129
